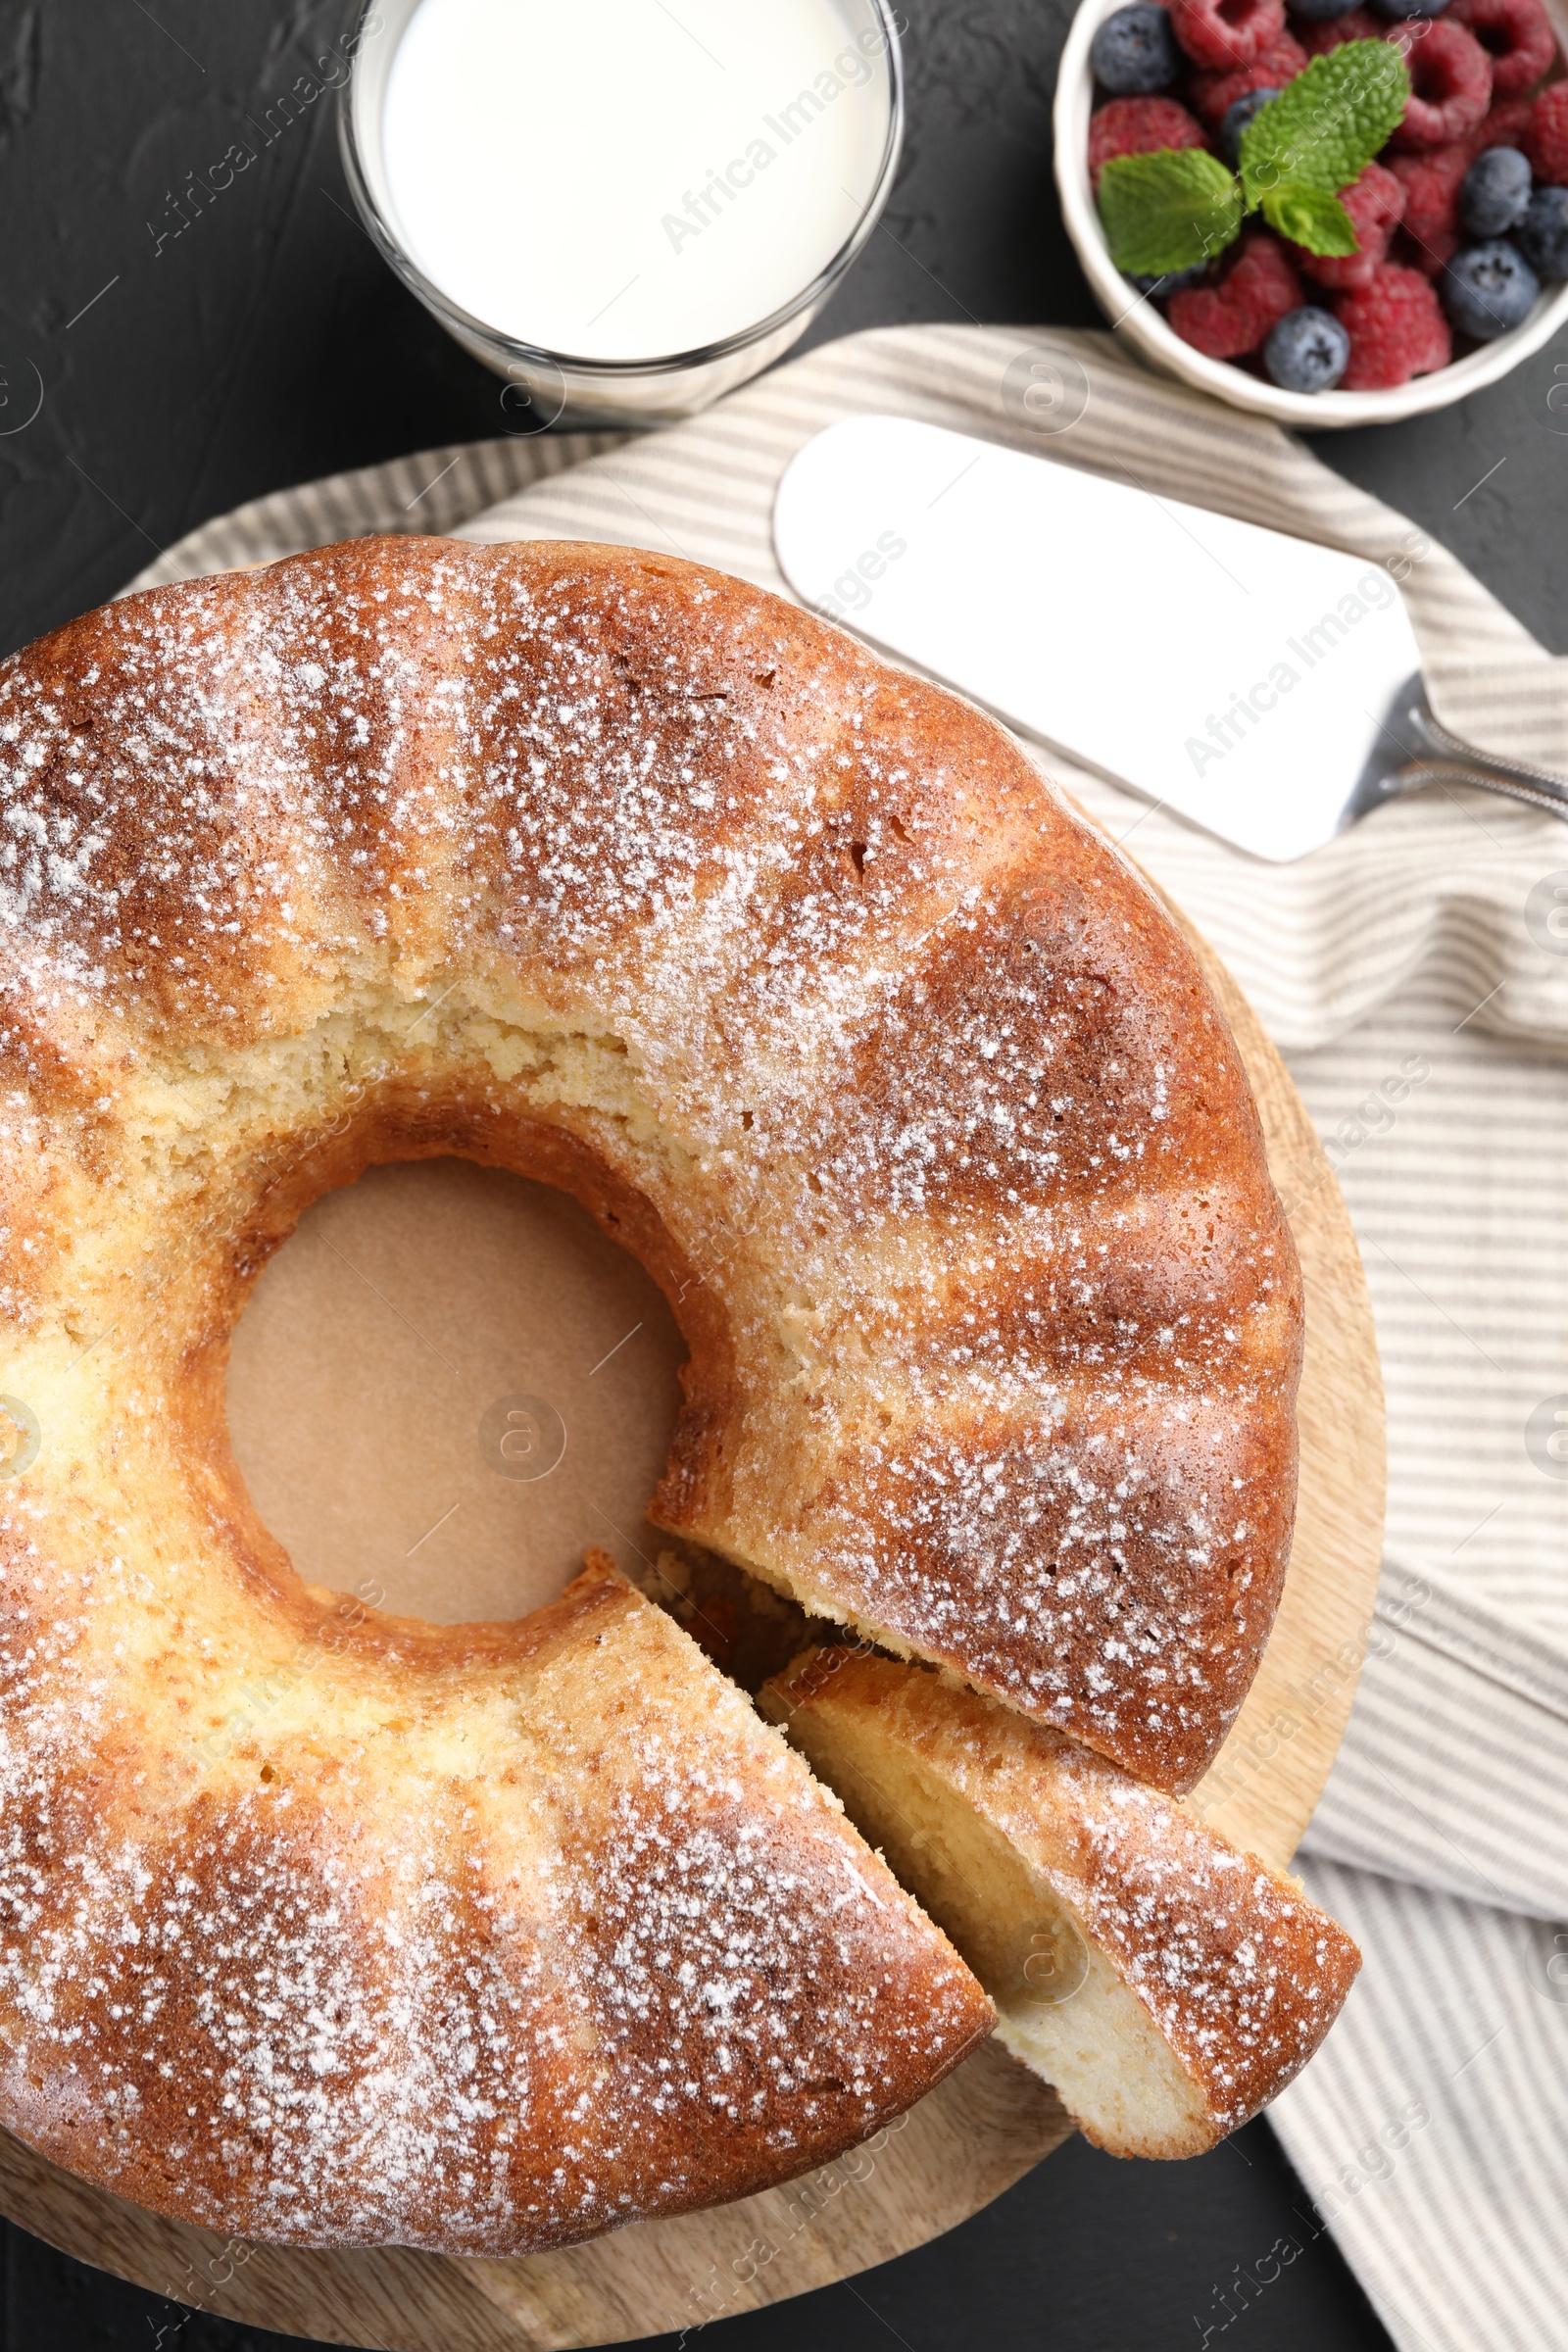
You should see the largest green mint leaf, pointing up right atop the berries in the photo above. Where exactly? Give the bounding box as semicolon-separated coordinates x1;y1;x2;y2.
1242;40;1410;204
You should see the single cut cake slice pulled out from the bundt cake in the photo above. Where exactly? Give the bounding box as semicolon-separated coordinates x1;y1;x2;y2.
760;1648;1361;2157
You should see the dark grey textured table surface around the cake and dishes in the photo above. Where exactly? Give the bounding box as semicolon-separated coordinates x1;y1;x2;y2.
0;0;1568;2352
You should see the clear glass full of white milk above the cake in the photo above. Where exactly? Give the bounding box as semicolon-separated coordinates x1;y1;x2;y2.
338;0;903;430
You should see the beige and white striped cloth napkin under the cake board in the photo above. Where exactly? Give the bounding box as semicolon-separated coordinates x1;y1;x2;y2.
134;327;1568;2352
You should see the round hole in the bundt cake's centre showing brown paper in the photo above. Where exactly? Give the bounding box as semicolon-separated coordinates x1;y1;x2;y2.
228;1159;686;1625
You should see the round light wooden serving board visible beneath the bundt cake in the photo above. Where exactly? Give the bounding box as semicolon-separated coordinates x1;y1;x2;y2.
0;907;1385;2352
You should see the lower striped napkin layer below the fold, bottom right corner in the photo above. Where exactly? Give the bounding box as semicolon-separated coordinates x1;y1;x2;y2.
1269;1860;1568;2352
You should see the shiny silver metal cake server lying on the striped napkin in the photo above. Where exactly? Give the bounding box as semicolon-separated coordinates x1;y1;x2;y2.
773;416;1568;860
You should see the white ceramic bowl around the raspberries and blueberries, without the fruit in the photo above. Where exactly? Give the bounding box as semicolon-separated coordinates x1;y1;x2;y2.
1054;0;1568;433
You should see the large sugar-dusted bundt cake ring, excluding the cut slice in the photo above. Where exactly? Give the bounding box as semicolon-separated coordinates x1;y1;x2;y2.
0;539;1300;2251
